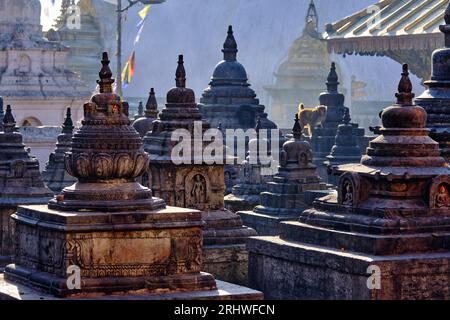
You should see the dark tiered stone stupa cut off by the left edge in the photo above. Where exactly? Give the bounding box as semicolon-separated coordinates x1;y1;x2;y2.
0;105;53;267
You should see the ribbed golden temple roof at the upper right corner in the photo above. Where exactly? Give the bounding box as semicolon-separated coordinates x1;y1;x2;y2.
323;0;448;53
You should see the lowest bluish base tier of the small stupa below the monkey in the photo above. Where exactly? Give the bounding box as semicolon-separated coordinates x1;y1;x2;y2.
237;211;298;236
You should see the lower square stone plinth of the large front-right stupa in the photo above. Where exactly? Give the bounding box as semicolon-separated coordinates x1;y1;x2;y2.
248;231;450;300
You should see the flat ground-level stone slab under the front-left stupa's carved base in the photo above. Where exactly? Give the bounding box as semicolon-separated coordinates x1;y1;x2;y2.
0;274;263;300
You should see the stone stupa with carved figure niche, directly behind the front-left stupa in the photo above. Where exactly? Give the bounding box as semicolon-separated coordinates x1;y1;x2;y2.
144;56;256;284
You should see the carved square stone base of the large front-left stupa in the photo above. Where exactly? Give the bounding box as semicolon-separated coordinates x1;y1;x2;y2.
5;205;216;297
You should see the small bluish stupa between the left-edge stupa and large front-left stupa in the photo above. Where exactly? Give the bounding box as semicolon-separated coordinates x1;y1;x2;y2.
42;108;77;194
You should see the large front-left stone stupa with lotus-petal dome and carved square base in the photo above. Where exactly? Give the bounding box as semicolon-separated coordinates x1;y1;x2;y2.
0;53;260;299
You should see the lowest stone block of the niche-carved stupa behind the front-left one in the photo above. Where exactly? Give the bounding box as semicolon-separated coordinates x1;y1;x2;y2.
202;244;248;286
